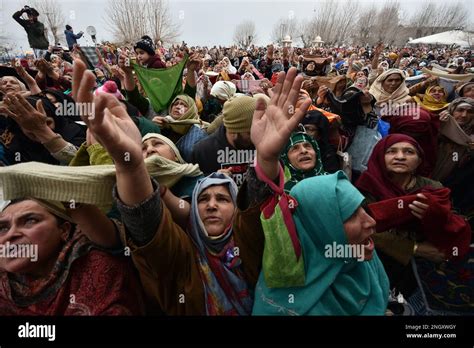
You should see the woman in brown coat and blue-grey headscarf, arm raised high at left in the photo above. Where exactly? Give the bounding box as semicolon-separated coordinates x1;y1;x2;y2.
73;57;267;315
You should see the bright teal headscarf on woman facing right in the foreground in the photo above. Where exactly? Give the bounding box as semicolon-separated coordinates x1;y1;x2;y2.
253;171;389;315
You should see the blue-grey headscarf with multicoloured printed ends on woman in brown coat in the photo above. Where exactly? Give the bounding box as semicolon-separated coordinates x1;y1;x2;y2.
188;173;252;315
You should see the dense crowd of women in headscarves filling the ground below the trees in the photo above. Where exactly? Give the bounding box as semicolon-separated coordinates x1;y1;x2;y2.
0;36;474;315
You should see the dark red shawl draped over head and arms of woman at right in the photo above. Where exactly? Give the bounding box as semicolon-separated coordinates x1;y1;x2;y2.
356;134;471;258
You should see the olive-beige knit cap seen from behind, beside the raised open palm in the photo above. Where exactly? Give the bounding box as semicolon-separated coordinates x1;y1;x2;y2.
222;95;257;133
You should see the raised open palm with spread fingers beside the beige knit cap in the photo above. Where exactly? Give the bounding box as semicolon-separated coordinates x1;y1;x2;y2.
250;68;311;180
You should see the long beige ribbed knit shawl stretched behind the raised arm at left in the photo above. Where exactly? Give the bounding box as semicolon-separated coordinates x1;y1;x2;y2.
0;156;202;211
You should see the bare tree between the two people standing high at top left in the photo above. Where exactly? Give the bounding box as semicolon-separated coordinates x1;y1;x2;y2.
30;0;65;44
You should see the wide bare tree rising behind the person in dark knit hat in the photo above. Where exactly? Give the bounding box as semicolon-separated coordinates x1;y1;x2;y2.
105;0;179;43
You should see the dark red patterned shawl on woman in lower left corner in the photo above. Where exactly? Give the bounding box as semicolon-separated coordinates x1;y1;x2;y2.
0;236;144;315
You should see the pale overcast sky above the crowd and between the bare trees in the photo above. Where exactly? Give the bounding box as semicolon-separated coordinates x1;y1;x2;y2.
0;0;474;50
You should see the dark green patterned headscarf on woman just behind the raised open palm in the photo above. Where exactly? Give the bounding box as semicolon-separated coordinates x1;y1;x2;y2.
280;132;327;193
